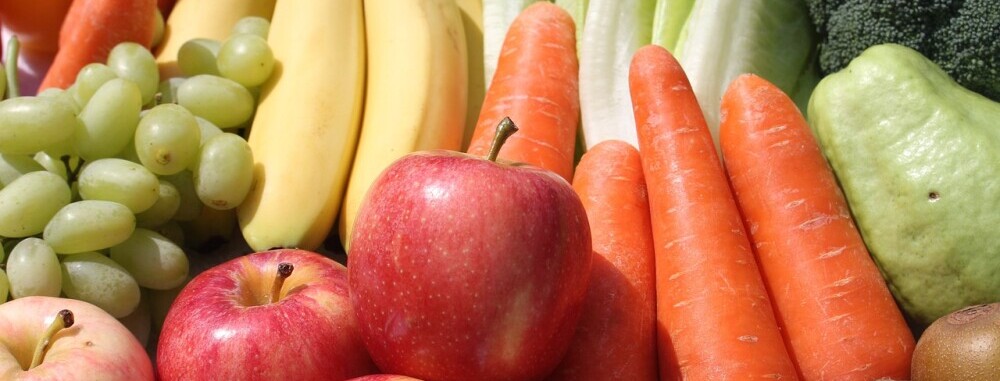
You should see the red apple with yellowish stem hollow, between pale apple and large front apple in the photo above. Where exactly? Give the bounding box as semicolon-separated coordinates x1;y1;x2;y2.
156;249;377;381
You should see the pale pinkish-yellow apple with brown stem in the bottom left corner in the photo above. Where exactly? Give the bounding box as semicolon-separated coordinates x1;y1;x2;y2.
0;296;153;381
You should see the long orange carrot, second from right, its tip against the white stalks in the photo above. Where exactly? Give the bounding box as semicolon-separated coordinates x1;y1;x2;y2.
629;45;796;380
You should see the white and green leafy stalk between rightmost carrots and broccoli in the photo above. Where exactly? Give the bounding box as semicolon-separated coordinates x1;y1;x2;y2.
673;0;816;151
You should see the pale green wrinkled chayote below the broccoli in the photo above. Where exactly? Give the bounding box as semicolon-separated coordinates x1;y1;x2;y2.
808;44;1000;327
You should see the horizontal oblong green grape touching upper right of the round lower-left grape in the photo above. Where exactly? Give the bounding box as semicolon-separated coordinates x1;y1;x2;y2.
42;200;135;254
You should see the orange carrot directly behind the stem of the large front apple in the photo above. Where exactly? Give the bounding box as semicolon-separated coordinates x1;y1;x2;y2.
468;2;580;181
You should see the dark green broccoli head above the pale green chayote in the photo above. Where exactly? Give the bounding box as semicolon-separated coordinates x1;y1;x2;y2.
805;0;1000;101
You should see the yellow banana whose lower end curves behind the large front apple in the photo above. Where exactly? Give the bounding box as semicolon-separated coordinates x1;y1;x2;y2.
338;0;469;248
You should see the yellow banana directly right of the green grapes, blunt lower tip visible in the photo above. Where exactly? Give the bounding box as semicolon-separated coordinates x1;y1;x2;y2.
237;0;365;251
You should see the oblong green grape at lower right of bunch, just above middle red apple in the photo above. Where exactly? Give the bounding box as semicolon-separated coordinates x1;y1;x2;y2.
111;228;189;290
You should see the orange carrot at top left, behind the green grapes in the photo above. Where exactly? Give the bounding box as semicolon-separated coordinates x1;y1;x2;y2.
38;0;156;92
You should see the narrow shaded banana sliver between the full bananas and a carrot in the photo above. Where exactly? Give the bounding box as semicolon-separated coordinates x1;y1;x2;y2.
455;0;486;151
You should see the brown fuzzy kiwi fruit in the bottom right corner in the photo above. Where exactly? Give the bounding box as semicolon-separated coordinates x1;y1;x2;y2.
911;302;1000;381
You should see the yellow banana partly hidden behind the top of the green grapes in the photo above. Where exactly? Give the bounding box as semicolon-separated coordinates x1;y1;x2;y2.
155;0;275;79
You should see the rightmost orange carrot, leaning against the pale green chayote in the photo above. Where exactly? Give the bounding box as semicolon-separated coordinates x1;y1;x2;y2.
719;75;914;380
